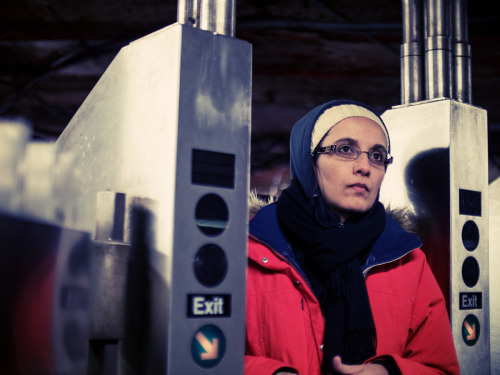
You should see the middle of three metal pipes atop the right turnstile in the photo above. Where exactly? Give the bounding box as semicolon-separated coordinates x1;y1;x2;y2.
424;0;453;99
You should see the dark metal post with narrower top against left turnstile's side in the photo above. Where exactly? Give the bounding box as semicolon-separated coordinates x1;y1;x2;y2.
88;192;134;375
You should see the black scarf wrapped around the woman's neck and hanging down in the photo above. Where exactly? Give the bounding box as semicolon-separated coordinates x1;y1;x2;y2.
277;180;385;374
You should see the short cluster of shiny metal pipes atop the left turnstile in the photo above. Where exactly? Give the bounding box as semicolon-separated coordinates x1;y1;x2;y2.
177;0;236;37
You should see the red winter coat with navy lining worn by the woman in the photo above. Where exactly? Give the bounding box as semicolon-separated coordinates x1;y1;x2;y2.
245;205;459;375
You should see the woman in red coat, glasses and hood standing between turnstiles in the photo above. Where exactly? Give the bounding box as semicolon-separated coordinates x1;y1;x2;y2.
245;101;459;375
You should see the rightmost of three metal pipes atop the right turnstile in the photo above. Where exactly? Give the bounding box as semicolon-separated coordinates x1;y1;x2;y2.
452;0;472;104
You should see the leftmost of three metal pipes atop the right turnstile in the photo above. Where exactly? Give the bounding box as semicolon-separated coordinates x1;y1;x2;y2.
400;0;425;104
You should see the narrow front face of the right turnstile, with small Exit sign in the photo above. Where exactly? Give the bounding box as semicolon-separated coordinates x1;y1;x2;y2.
450;101;490;374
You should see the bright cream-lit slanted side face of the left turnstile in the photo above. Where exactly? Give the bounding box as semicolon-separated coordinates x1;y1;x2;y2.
56;26;181;251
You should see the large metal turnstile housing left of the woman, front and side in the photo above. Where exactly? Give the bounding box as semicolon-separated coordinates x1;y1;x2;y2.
56;24;251;374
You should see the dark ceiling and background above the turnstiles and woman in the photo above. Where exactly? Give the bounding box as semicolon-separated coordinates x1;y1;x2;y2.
0;0;500;193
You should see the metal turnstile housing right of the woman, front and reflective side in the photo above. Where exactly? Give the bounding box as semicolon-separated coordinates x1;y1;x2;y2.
381;99;490;374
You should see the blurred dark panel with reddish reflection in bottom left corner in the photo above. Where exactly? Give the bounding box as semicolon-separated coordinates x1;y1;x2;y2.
0;214;61;375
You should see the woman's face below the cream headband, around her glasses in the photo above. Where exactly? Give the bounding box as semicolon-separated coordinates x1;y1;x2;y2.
314;117;387;222
